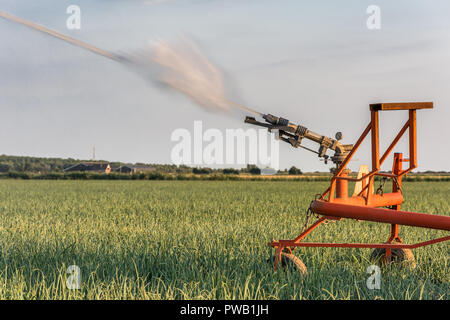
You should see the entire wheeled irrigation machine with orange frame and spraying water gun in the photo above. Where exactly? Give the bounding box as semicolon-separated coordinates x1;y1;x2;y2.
245;102;450;274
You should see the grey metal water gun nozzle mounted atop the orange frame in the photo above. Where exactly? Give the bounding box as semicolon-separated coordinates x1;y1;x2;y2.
245;114;353;168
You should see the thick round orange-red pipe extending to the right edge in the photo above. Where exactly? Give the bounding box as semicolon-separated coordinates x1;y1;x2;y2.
311;200;450;231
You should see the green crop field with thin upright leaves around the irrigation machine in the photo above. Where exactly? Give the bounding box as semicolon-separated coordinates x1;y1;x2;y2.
0;180;450;299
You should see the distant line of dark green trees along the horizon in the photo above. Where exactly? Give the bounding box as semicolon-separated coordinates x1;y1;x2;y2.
0;155;450;181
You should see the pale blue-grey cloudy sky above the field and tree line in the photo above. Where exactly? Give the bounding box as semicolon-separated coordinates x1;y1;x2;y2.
0;0;450;171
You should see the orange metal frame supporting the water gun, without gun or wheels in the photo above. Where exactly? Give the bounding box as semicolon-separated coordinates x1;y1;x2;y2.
269;102;450;269
